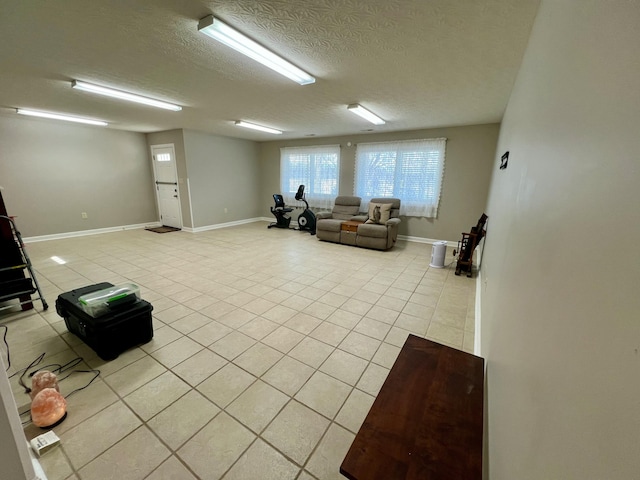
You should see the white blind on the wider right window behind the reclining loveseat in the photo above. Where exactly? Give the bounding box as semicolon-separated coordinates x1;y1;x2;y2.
354;138;447;218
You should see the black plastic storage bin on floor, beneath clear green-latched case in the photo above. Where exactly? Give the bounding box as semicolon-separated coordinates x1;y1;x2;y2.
56;282;153;360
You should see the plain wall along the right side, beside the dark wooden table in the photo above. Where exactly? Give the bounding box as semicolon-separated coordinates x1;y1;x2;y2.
481;0;640;480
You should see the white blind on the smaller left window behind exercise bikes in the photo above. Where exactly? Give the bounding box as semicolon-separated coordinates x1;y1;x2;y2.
280;145;340;208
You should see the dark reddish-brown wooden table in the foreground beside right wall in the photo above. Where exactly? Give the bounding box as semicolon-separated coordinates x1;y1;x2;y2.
340;335;484;480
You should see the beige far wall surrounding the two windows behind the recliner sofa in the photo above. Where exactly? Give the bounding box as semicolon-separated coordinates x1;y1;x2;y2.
260;124;499;242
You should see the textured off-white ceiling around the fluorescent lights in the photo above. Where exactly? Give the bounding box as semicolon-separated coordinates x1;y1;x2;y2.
0;0;539;141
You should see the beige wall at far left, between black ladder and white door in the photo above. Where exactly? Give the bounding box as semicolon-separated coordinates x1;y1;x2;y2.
0;115;157;237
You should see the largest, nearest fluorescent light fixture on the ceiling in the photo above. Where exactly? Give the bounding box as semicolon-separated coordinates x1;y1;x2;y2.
198;15;316;85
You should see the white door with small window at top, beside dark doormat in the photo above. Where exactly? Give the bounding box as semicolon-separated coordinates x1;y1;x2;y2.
151;144;182;228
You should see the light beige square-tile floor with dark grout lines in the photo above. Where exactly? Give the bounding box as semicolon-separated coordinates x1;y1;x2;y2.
0;222;475;480
